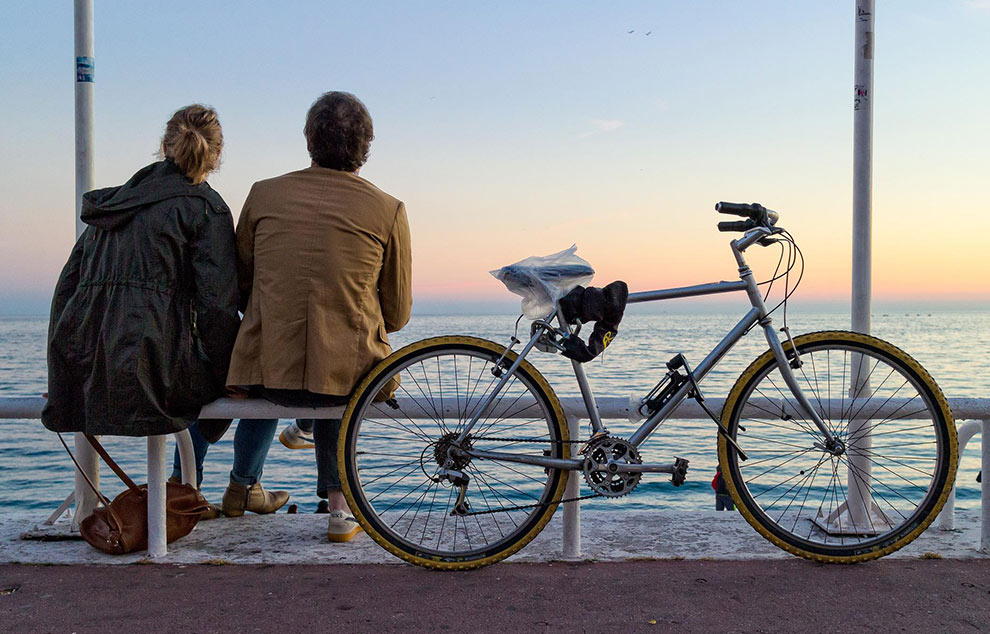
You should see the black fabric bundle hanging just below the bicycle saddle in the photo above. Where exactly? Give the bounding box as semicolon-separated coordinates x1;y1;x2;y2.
560;280;629;363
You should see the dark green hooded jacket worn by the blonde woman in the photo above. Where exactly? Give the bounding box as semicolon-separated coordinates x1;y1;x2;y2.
41;160;239;436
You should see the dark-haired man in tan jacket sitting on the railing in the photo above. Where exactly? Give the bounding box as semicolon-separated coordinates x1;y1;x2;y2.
223;92;412;541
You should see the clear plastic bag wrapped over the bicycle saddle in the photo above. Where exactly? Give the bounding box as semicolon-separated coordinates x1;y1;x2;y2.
491;244;595;319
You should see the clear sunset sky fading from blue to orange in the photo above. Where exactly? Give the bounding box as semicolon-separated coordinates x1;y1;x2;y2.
0;0;990;314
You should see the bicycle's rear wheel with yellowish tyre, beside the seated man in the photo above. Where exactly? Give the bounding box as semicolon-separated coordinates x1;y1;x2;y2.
338;336;570;570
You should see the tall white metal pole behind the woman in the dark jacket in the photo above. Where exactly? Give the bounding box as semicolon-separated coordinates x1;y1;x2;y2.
72;0;100;529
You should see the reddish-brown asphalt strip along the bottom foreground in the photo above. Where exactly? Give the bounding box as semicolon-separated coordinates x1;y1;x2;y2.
0;559;990;634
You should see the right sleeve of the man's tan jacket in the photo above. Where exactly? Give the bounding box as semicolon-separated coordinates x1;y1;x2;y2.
378;202;412;332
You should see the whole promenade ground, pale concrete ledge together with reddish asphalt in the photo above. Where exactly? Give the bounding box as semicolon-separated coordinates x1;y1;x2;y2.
0;510;990;634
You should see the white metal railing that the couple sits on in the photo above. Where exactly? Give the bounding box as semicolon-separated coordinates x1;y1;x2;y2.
0;397;990;559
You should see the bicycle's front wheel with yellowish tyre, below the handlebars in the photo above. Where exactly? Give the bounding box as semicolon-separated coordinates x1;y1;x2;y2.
719;331;958;563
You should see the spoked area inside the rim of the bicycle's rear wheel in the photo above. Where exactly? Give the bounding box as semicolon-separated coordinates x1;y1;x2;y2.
354;352;561;554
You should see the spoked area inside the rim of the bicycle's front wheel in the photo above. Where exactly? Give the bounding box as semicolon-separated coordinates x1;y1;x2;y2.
736;345;941;547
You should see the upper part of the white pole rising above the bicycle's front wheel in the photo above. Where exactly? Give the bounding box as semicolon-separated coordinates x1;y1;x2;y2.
852;0;874;334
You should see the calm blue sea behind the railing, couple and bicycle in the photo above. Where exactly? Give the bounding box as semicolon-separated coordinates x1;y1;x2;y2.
0;306;990;521
